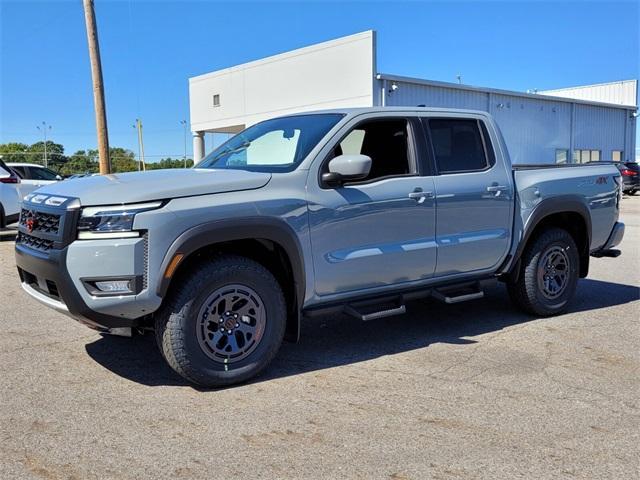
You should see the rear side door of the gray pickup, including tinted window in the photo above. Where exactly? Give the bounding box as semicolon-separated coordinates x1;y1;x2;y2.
422;116;514;277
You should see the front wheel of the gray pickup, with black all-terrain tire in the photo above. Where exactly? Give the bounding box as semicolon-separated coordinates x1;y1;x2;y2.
155;255;286;387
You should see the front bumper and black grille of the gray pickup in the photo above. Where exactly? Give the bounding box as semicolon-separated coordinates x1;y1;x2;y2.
15;194;162;331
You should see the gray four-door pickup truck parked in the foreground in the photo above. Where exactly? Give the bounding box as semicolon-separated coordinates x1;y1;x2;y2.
16;108;624;387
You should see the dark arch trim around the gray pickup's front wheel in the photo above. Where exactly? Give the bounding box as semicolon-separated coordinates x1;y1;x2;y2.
156;217;305;341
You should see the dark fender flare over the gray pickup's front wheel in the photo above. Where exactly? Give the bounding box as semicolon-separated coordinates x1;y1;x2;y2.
156;216;306;341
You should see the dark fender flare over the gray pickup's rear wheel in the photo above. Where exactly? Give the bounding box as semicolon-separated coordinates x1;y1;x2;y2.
507;195;592;276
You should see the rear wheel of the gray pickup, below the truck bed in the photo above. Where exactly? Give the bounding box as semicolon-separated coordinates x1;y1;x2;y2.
507;228;580;316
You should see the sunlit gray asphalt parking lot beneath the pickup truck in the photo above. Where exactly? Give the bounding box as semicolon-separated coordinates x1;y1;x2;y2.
0;196;640;480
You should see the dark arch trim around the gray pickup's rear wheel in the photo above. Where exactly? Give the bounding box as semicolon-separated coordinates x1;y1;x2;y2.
506;195;592;281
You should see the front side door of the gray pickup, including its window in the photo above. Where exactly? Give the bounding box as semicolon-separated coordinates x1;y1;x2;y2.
308;117;436;296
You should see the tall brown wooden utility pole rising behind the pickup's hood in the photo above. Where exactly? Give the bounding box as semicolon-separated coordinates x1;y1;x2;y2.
82;0;111;175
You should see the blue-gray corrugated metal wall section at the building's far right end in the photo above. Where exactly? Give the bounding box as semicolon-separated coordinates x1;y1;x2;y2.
574;104;630;160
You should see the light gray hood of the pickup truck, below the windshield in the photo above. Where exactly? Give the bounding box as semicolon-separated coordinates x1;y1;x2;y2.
41;168;271;205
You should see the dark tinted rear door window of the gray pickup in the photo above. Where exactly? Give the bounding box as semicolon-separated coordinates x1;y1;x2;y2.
428;119;490;173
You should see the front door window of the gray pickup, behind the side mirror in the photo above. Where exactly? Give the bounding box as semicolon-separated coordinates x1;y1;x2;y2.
331;118;415;182
